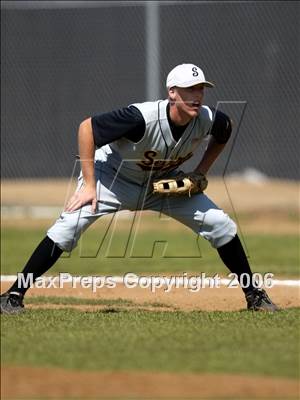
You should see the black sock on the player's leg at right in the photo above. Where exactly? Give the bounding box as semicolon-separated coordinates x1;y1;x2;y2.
217;235;254;293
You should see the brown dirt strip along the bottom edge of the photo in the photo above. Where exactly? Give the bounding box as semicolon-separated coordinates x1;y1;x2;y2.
1;366;299;400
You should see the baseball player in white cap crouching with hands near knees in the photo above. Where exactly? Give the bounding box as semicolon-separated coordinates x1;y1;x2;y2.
1;64;278;314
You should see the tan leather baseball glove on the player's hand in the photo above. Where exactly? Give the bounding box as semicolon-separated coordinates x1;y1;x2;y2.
153;172;208;197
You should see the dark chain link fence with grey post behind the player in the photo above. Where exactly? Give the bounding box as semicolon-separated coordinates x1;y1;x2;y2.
1;1;300;179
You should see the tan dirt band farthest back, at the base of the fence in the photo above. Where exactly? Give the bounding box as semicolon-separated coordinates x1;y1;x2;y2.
1;178;300;234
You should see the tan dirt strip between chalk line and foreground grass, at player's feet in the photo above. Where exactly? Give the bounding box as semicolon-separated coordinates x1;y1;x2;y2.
1;282;300;311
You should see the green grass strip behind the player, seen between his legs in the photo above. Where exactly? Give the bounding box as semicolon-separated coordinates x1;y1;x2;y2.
1;228;300;278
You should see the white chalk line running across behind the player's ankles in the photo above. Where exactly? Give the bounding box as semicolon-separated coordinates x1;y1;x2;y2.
0;274;300;287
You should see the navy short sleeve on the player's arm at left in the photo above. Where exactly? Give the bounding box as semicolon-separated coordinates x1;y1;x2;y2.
92;106;145;147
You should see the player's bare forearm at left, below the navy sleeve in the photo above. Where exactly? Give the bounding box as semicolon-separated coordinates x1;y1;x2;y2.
78;118;96;187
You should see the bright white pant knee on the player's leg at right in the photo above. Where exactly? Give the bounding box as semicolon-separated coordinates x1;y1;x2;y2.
194;209;237;248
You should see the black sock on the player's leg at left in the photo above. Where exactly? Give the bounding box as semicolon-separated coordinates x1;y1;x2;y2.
9;236;63;295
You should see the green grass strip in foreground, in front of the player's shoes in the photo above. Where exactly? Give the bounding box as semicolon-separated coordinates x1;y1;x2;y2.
1;309;300;379
